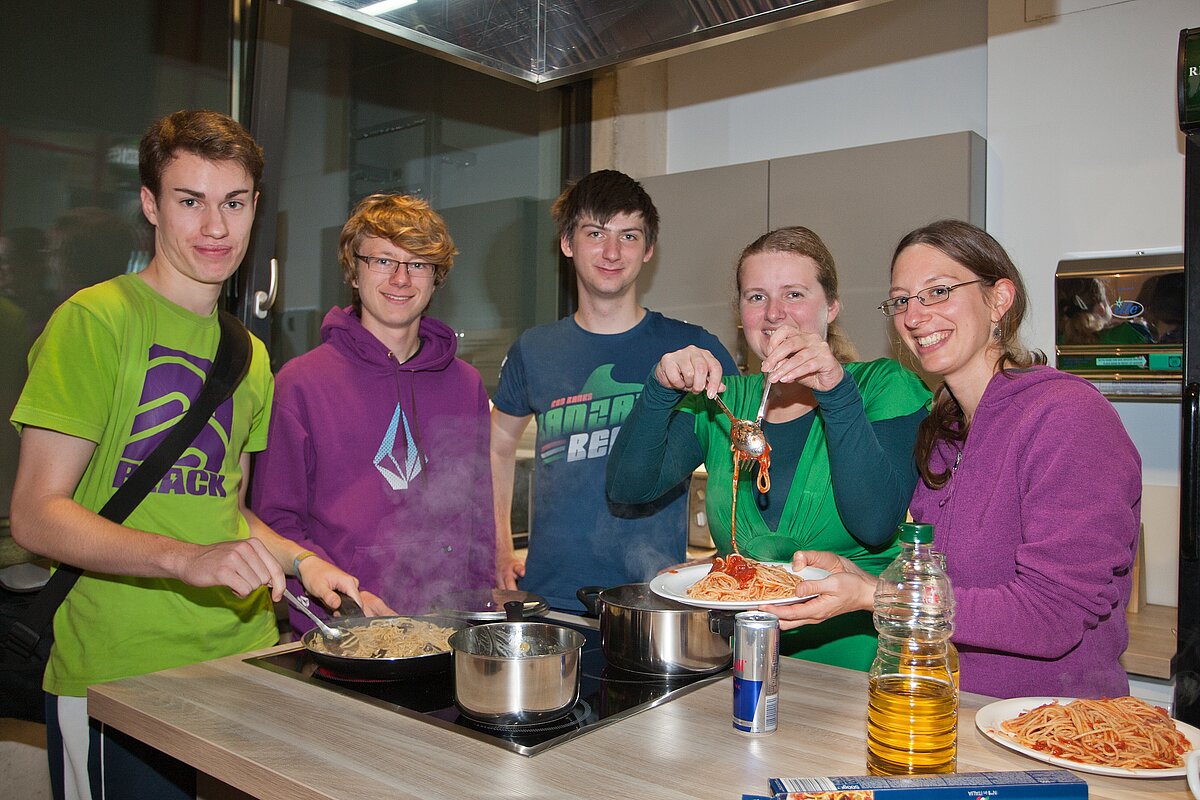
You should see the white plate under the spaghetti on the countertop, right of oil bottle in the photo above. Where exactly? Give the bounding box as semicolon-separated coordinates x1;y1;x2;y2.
976;697;1200;778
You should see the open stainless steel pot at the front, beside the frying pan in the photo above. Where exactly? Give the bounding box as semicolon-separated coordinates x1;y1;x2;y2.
450;622;583;724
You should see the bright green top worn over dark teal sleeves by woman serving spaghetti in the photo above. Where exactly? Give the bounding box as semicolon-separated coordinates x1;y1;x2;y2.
680;359;929;670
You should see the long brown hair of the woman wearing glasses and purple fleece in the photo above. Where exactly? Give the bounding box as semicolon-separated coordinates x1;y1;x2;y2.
892;219;1046;489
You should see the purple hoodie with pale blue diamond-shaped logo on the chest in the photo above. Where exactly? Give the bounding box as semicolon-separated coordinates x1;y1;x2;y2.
252;308;496;631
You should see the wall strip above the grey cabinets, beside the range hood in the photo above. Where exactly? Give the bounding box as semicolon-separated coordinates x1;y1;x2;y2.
666;0;988;173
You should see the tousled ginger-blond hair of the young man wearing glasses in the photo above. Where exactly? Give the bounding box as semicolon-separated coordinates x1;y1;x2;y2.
337;194;458;308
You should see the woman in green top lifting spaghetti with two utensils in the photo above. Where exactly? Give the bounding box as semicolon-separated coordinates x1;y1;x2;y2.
607;227;930;670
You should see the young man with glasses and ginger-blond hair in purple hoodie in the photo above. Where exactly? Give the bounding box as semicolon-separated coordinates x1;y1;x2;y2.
253;194;496;631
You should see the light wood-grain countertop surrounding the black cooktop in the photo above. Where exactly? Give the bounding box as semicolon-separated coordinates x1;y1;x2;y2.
88;645;1192;800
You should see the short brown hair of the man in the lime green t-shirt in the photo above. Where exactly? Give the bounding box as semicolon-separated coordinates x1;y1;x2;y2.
138;110;263;197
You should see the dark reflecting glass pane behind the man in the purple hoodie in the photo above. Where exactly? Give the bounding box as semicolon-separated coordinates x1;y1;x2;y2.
252;0;564;390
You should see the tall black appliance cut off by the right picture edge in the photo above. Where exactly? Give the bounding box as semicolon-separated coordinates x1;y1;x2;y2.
1171;28;1200;726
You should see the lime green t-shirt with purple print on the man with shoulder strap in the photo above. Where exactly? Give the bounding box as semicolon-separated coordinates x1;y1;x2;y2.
12;275;278;697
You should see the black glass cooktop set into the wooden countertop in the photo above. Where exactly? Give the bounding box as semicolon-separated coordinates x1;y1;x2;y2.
246;620;731;756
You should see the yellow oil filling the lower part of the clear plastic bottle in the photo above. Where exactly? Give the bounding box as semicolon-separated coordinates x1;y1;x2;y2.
866;674;958;775
